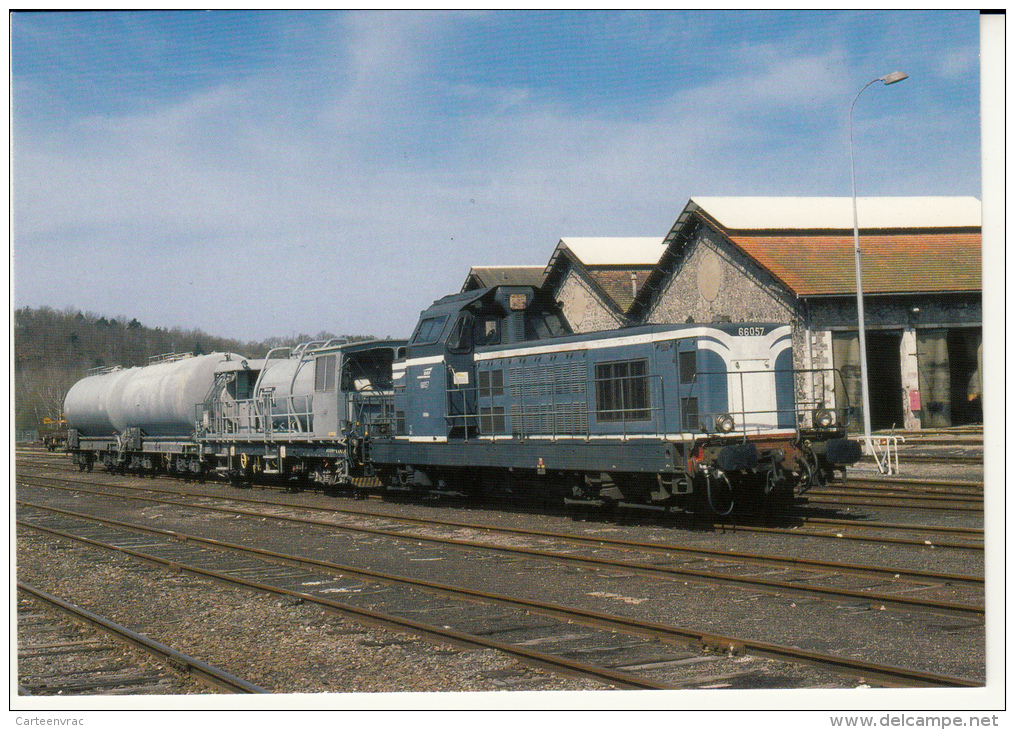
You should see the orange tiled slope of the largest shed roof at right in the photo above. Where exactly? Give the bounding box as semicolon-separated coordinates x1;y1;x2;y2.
729;231;983;296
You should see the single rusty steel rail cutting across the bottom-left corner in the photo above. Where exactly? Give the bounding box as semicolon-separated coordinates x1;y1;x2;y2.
17;581;268;694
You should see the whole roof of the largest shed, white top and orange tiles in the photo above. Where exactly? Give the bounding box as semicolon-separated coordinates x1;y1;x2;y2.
627;197;983;319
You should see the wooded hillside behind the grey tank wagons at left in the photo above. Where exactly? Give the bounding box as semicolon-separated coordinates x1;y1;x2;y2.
14;307;369;432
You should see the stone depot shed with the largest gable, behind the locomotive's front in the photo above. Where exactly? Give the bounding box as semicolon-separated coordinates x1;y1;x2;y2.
625;197;983;429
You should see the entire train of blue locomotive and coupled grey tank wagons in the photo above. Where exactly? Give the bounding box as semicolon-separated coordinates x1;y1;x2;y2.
65;286;861;514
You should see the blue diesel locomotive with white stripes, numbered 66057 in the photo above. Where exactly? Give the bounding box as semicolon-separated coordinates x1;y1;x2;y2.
370;286;861;514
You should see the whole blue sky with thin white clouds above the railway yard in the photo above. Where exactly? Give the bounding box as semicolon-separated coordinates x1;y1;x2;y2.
10;10;980;339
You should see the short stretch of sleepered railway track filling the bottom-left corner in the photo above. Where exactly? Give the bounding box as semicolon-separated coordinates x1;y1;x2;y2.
17;581;267;695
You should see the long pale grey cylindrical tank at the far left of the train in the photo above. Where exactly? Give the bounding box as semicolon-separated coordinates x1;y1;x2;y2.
64;352;243;438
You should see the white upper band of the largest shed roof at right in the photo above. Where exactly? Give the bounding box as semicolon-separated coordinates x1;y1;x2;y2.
685;196;982;230
